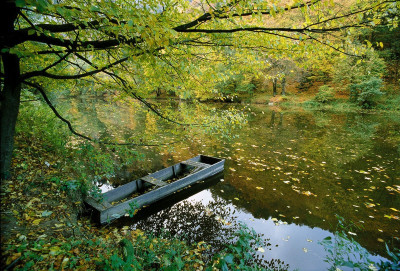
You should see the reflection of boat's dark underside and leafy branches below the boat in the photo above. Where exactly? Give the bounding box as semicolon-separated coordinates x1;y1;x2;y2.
113;174;289;270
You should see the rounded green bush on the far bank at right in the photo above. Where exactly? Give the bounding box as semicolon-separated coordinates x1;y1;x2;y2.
350;77;383;109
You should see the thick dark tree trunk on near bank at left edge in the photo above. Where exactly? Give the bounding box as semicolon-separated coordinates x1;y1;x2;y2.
0;54;21;179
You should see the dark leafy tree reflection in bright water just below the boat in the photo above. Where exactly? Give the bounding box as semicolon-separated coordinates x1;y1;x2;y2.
132;200;289;270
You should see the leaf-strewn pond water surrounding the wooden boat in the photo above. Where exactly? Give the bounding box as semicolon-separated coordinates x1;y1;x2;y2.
64;100;400;270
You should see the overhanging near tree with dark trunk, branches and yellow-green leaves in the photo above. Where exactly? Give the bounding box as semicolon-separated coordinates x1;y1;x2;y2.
1;0;400;178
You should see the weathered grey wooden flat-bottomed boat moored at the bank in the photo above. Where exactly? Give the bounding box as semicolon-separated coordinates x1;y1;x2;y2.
85;155;225;224
